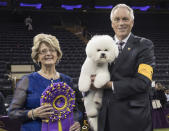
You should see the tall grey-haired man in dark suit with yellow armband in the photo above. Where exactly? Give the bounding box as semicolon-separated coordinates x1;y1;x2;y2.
94;4;155;131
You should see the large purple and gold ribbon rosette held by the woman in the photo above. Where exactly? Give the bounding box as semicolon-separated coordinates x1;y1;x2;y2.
40;82;75;131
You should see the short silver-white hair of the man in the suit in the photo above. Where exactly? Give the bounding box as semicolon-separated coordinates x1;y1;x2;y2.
110;4;134;21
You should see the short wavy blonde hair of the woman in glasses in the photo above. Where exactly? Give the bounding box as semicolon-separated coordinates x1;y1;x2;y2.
31;33;62;64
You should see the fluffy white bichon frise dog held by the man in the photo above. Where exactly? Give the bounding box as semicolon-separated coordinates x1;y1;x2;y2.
78;35;119;131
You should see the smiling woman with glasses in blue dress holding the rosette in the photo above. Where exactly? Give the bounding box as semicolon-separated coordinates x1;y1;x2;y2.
9;34;80;131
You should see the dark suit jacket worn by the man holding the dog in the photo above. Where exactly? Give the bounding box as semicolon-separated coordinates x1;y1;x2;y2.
98;34;155;131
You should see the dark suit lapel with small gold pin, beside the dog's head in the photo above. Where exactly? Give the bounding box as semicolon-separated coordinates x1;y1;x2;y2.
113;34;134;71
